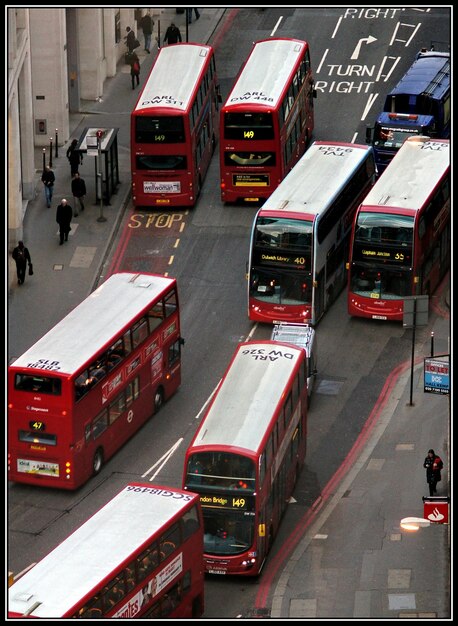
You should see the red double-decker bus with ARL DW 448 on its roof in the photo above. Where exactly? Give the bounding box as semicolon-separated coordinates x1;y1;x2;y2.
220;38;316;202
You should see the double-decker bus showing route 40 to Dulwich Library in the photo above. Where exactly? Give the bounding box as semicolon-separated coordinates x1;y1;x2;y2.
248;141;376;325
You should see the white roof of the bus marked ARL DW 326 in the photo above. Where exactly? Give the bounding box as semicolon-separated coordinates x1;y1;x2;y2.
191;341;306;452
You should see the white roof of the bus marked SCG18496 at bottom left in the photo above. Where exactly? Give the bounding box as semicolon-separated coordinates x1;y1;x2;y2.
8;483;198;618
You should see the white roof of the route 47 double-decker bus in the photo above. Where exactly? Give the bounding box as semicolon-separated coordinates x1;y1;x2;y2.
12;272;175;375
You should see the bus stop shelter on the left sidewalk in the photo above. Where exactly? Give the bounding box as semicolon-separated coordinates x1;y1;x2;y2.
76;127;121;205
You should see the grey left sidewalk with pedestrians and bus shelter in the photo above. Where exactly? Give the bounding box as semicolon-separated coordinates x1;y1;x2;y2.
6;8;225;362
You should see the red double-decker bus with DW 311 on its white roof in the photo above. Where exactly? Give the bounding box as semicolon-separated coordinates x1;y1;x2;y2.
131;43;221;207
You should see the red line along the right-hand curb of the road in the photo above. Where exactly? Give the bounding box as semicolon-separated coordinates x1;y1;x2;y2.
255;358;414;608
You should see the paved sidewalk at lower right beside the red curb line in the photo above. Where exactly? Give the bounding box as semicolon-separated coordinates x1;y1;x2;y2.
268;289;451;619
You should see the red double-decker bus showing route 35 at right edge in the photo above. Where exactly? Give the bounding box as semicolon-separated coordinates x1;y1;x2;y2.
348;136;451;321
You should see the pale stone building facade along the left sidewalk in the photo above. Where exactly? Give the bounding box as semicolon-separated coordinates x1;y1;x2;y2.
5;7;157;249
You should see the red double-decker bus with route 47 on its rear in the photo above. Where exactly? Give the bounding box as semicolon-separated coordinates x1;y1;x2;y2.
8;272;183;489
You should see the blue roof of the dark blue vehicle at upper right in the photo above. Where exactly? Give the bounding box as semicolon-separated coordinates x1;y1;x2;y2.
388;52;450;100
